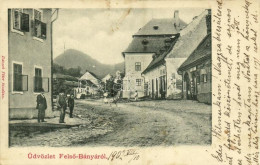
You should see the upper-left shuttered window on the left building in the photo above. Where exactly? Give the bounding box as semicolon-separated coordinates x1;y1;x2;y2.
12;9;29;32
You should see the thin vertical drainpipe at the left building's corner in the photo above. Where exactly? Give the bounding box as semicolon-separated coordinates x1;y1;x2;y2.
50;9;59;110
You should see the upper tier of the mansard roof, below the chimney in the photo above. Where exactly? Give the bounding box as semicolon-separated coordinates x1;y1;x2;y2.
134;18;187;36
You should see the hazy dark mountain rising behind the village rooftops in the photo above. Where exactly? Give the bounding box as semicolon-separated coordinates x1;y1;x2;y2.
54;49;124;79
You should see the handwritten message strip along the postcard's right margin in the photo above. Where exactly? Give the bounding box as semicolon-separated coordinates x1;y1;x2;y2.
211;0;260;165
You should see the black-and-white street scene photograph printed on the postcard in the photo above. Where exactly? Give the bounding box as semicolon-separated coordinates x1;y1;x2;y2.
8;7;212;147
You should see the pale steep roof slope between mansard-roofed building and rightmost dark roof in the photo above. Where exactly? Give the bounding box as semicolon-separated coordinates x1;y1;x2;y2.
167;10;211;58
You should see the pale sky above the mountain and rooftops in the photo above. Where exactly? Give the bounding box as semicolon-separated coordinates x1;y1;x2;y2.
53;8;205;64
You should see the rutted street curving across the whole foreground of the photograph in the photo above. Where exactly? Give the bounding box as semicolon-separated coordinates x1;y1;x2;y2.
10;100;211;147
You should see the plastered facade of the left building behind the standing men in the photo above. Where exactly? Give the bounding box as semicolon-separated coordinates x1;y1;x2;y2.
8;9;52;119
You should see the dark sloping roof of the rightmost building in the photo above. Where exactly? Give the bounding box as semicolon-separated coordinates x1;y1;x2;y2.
178;33;212;71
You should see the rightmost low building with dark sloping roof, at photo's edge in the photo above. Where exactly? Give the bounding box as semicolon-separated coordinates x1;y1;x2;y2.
178;33;212;104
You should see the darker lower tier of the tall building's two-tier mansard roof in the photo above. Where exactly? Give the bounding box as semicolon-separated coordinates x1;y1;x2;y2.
123;37;177;55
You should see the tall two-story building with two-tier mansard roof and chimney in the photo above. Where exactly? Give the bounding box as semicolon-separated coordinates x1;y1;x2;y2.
122;11;186;98
